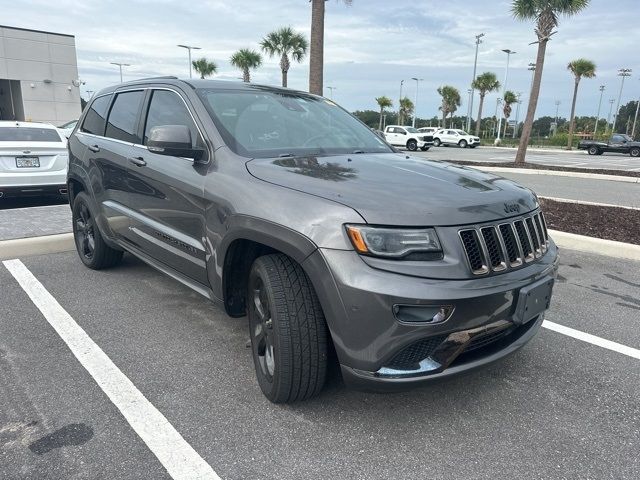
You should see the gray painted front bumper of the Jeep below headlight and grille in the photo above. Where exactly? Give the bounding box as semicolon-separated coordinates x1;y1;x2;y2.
303;241;558;387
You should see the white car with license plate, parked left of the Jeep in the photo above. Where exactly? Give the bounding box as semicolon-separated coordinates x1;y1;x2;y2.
0;121;69;198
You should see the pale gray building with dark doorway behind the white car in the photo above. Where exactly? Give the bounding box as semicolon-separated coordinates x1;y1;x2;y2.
0;25;80;126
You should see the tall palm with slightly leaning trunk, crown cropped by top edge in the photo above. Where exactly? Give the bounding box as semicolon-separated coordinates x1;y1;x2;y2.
511;0;589;163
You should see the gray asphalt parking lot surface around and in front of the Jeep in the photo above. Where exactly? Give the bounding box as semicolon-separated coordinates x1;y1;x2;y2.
0;250;640;479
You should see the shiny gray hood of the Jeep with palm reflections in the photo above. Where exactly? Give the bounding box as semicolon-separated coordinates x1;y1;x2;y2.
247;153;538;226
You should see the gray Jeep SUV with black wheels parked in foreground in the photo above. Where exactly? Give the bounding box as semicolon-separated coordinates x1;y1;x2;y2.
68;78;557;402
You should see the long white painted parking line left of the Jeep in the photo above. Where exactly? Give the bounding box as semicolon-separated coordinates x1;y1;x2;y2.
2;260;220;480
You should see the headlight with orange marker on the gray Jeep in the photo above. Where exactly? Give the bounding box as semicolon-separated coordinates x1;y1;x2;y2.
346;225;442;258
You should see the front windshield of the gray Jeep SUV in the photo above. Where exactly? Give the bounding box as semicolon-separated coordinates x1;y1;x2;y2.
198;89;392;158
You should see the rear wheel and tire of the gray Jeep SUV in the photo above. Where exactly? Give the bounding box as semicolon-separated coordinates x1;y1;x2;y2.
72;192;124;270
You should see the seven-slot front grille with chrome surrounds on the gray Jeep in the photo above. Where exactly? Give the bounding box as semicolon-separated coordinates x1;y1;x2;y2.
459;212;549;275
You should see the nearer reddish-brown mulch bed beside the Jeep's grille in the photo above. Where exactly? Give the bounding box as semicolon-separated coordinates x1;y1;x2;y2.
540;198;640;245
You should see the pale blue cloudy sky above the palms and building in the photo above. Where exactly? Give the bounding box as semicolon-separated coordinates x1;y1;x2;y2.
5;0;640;118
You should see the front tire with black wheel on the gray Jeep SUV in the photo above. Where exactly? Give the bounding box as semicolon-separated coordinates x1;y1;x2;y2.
247;253;328;403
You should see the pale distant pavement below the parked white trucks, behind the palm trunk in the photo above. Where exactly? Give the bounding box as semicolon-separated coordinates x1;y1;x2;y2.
413;146;640;172
